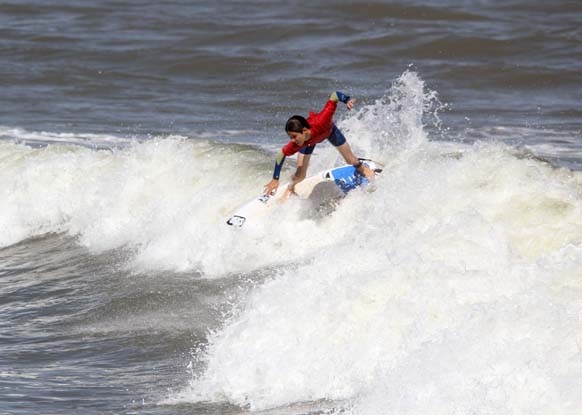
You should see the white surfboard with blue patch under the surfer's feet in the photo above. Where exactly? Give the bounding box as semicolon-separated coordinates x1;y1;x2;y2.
226;159;384;228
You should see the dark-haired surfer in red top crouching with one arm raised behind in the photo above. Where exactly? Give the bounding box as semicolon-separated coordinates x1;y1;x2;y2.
265;91;374;195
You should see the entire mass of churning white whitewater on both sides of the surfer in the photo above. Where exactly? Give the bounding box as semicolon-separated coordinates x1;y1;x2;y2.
0;72;582;414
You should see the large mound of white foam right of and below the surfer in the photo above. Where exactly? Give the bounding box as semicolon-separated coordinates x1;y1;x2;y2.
168;74;582;414
